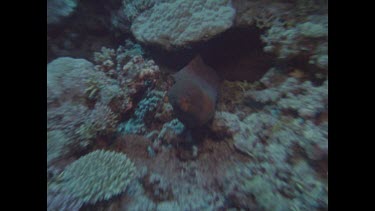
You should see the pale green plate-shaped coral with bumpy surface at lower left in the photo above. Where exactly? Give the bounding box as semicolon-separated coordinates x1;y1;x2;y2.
51;150;135;204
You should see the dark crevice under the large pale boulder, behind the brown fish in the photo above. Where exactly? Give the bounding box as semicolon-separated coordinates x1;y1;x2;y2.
146;27;274;81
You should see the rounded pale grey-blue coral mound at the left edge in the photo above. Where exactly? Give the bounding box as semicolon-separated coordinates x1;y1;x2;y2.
47;58;122;145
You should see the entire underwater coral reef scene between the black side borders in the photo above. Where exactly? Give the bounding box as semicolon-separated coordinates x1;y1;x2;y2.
46;0;328;211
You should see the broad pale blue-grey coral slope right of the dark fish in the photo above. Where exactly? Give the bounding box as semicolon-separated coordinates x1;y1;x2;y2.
211;69;328;210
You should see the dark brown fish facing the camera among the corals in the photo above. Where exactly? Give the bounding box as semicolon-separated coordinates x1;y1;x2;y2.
168;55;220;128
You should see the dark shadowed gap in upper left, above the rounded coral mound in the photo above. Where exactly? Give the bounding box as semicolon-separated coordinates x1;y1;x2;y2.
47;0;128;63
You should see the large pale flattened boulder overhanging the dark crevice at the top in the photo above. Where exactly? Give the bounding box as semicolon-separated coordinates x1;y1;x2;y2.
131;0;235;49
